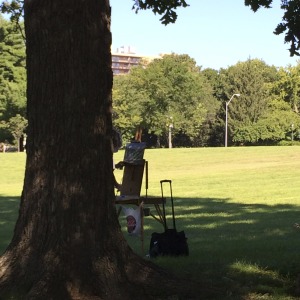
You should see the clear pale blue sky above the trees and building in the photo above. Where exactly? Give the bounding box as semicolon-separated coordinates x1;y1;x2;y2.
110;0;300;70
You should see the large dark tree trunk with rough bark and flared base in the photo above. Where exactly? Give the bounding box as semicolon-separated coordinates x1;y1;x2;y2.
0;0;195;300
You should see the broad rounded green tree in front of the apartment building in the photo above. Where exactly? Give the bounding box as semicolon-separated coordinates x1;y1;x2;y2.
113;54;217;148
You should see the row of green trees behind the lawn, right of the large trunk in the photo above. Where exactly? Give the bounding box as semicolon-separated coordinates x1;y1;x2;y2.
113;54;300;146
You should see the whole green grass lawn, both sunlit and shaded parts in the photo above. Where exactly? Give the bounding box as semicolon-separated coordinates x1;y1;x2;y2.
0;146;300;300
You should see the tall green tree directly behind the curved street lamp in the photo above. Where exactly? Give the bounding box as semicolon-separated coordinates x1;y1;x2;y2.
219;59;276;143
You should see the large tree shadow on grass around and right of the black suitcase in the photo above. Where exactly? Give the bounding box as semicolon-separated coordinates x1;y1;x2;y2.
121;198;300;299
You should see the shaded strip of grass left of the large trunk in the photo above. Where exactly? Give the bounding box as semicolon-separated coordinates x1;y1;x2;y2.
0;196;20;255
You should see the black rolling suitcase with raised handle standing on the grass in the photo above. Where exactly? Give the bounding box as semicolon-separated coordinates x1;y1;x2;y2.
149;180;189;258
